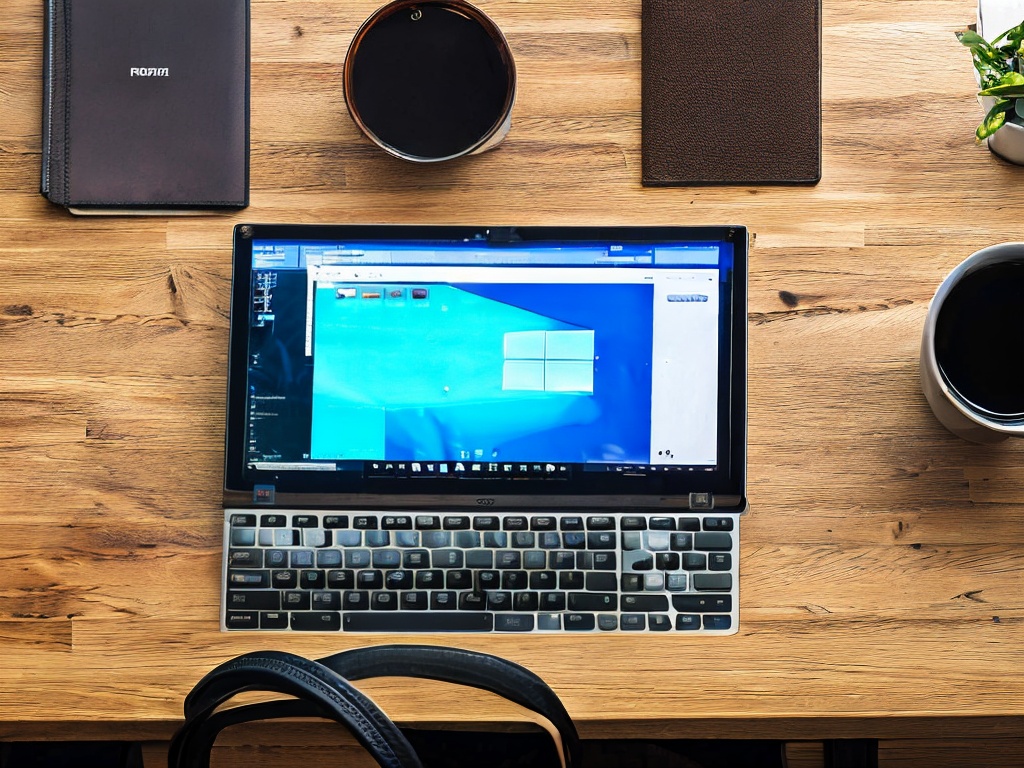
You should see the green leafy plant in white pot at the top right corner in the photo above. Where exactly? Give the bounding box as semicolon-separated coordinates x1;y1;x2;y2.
956;22;1024;165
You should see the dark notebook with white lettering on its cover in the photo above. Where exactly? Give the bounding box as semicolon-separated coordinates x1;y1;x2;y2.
41;0;249;213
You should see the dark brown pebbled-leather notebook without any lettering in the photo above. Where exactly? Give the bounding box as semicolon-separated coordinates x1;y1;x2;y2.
641;0;821;186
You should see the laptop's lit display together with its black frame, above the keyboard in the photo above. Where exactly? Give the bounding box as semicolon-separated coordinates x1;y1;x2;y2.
225;225;746;504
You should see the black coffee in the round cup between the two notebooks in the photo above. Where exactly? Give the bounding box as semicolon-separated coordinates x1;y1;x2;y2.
349;3;512;158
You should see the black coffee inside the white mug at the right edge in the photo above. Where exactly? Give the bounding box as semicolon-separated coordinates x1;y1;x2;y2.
935;262;1024;418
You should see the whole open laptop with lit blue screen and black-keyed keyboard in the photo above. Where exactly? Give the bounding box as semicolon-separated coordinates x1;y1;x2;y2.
220;224;748;635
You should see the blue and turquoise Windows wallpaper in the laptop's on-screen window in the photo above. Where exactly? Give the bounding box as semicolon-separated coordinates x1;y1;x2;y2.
310;283;653;464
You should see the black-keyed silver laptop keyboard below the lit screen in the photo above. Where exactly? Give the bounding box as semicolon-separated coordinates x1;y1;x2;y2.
222;510;739;634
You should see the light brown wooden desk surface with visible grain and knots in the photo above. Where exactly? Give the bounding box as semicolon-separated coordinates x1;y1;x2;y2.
0;0;1024;757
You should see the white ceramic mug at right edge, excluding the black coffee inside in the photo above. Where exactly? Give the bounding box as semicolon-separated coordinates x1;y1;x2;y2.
921;243;1024;443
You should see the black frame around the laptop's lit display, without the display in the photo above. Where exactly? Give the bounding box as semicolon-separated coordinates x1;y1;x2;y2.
224;224;748;509
